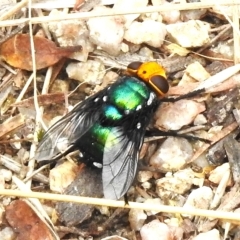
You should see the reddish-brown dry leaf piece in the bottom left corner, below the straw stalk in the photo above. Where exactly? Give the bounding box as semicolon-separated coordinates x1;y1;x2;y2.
6;200;53;240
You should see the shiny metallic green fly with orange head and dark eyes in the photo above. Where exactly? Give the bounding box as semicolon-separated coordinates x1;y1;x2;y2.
35;62;202;199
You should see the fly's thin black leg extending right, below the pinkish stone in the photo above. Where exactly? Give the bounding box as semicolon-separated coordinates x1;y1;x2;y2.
145;129;211;143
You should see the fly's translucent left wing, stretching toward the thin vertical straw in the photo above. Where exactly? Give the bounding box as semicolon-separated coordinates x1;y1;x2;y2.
35;90;106;164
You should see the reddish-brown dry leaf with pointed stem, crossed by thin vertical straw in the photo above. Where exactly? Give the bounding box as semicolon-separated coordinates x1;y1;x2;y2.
0;34;81;71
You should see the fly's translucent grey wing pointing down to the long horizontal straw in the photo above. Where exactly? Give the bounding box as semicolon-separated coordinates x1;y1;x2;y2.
102;127;145;199
